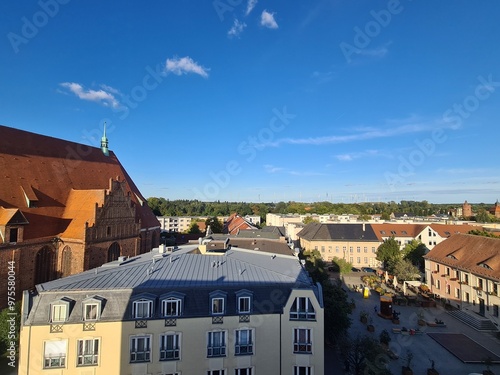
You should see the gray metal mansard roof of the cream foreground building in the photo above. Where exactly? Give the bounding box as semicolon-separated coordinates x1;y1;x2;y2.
25;245;321;324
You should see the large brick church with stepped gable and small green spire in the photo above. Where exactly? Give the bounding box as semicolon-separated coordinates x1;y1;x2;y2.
0;126;160;308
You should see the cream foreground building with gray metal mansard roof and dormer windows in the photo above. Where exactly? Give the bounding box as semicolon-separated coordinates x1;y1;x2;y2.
19;245;324;375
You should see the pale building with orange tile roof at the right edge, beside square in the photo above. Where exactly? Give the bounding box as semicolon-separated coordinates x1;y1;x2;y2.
424;234;500;327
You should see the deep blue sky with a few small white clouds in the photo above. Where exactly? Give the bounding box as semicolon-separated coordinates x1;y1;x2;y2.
0;0;500;203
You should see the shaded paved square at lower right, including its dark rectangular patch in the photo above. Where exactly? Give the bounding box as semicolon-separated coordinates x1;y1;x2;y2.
342;276;500;375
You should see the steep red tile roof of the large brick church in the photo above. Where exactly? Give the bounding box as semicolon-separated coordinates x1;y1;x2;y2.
0;126;159;240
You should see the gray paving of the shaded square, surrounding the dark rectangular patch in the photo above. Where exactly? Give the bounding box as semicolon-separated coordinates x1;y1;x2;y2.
348;284;500;375
